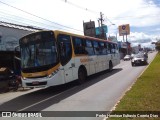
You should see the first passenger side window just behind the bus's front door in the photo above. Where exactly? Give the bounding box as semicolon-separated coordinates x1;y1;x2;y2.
72;37;86;54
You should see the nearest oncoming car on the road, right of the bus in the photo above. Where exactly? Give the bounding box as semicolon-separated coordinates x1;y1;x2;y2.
131;54;148;66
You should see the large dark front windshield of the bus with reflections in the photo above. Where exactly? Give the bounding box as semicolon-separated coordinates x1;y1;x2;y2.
20;32;58;68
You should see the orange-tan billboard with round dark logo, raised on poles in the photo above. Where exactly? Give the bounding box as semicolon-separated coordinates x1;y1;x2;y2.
118;24;130;36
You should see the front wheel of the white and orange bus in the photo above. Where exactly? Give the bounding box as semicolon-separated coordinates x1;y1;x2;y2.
77;67;87;85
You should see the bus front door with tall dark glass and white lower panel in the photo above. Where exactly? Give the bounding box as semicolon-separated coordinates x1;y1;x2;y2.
58;34;73;82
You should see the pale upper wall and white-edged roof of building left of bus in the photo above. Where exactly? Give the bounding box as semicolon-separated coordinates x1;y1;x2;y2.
0;21;42;51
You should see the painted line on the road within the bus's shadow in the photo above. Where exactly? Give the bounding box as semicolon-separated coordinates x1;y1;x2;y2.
18;86;77;112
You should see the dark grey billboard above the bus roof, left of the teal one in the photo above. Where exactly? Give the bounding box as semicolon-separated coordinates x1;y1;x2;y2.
83;21;96;37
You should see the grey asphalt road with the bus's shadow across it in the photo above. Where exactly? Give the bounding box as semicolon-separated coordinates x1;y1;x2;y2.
0;52;156;120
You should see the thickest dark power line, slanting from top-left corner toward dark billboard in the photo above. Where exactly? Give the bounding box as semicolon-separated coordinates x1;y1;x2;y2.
0;1;82;32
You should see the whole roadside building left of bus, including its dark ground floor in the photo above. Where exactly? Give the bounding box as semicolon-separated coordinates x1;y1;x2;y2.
0;21;42;70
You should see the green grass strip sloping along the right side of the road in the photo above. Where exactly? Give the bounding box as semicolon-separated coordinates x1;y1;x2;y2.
109;52;160;120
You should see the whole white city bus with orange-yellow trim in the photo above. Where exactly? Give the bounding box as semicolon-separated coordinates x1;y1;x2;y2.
19;30;120;87
